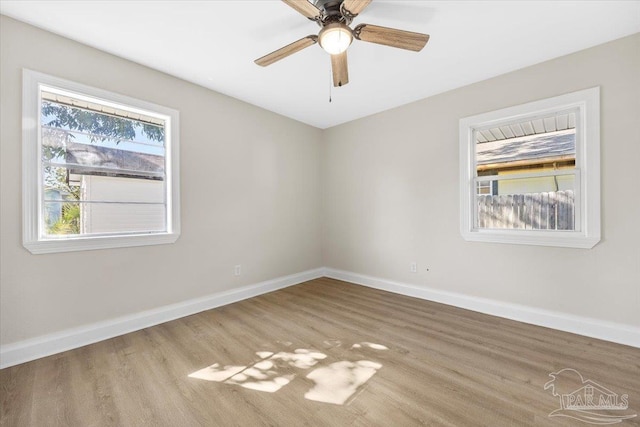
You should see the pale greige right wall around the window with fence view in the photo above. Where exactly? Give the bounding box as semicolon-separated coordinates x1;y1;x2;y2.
322;34;640;327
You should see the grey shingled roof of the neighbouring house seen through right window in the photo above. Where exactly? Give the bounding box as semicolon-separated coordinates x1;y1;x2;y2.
476;129;576;165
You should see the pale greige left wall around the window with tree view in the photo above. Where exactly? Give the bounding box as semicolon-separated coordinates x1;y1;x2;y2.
0;16;322;345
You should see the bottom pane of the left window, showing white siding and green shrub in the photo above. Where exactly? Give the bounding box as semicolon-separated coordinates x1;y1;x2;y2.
44;201;166;237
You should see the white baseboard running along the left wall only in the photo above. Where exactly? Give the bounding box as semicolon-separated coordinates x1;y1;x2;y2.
0;268;324;369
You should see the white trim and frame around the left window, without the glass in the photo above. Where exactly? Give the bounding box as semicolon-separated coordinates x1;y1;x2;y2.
22;69;180;254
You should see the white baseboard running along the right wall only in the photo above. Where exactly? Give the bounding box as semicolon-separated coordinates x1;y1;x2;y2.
324;268;640;348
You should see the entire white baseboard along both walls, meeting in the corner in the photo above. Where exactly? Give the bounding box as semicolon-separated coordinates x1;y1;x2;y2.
0;268;640;369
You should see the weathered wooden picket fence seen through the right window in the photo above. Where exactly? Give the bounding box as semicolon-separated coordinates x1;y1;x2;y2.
476;190;575;230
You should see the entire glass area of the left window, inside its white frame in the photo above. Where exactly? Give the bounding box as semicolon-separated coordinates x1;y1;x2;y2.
41;91;167;238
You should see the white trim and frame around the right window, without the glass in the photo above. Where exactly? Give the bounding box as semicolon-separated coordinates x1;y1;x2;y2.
460;87;600;248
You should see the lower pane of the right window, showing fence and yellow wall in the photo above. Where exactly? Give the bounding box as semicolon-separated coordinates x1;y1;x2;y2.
476;175;575;230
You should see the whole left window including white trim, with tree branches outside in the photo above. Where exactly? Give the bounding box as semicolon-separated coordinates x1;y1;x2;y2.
23;70;180;254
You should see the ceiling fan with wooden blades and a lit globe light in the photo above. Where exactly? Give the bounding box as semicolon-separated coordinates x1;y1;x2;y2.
254;0;429;87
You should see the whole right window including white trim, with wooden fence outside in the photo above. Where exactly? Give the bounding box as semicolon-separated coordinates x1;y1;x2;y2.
460;88;600;248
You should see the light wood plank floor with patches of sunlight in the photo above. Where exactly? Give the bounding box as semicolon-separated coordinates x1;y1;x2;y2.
0;278;640;427
